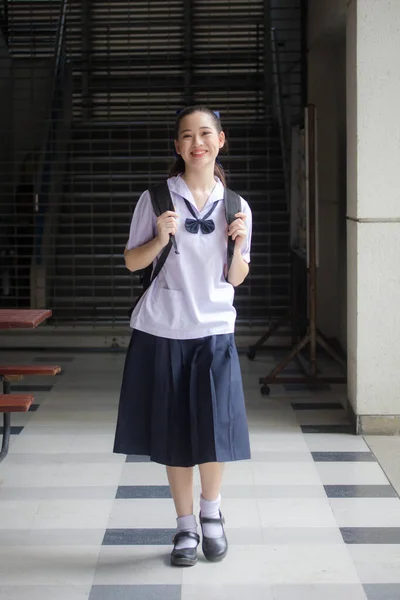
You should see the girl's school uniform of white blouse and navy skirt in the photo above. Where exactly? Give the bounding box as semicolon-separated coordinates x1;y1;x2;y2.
114;175;252;467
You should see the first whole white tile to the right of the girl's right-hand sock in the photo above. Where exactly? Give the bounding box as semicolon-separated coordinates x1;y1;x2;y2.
257;498;337;527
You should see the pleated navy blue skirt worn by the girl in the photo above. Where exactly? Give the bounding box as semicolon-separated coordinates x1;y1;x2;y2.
114;330;250;467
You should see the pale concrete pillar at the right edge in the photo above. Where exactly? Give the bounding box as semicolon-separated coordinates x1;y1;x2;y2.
346;0;400;433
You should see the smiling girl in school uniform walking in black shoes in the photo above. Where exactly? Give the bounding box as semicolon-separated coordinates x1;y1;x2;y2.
114;106;251;566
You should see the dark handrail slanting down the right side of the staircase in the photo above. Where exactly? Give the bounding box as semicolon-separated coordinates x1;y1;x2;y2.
271;27;290;210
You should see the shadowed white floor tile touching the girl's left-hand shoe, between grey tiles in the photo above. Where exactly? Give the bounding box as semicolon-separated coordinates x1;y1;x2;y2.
94;546;182;585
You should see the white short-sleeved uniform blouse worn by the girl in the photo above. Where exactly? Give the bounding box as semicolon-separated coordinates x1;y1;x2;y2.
126;175;252;340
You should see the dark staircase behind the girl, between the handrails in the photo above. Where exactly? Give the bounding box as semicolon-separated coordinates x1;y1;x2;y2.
4;0;300;326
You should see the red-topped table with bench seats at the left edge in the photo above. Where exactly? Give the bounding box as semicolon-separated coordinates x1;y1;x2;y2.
0;365;61;462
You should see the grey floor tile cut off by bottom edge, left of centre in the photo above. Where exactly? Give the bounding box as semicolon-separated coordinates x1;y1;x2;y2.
89;585;181;600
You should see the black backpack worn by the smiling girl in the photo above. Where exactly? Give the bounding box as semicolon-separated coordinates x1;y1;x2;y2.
130;181;242;315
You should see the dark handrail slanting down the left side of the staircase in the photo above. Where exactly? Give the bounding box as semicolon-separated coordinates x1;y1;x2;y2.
34;0;68;206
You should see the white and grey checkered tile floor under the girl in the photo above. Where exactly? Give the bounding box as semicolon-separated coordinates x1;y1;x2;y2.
0;344;400;600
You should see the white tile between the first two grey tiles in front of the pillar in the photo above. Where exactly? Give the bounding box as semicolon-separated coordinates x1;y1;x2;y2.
316;462;389;485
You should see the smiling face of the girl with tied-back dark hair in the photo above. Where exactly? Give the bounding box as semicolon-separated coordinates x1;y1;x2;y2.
175;112;225;168
